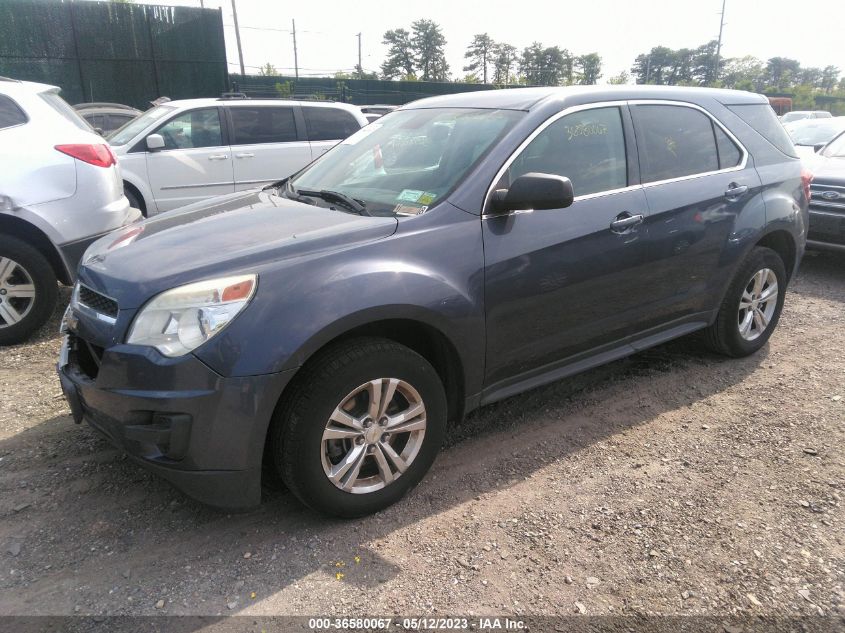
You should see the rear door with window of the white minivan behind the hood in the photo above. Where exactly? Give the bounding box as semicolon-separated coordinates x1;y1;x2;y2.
226;105;311;191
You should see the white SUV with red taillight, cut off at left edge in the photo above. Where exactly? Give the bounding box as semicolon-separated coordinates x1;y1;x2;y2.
0;78;139;345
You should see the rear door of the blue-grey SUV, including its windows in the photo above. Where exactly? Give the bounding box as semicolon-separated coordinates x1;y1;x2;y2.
630;101;765;326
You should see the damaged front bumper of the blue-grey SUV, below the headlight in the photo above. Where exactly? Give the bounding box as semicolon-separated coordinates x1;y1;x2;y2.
58;332;293;510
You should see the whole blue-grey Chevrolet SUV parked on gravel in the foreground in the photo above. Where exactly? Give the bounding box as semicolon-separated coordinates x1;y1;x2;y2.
59;86;810;516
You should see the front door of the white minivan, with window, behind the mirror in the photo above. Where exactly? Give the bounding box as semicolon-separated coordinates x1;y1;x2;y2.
146;107;235;211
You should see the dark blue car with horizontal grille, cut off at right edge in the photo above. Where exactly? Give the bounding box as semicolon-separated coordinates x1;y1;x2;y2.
807;132;845;251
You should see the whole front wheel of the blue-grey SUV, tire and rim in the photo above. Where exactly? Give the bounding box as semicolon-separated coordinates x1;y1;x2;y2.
272;338;446;517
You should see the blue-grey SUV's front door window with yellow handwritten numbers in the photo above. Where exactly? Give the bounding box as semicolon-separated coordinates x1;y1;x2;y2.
496;107;628;196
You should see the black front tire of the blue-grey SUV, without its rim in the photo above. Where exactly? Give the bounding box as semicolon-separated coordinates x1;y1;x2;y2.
282;344;447;518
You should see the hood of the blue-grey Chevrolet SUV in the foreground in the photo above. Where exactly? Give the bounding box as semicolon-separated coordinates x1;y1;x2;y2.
79;190;397;309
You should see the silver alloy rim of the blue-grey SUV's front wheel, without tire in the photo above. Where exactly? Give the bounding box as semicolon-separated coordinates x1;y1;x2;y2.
321;378;426;494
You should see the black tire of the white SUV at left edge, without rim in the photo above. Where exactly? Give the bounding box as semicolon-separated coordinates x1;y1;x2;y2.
0;235;58;345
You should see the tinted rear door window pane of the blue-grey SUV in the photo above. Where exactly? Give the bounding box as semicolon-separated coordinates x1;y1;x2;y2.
632;105;719;182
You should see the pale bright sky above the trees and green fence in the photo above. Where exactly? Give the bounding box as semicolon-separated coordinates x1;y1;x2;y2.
148;0;845;83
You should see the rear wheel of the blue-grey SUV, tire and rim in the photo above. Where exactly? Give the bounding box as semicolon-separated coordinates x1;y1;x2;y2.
704;247;786;357
